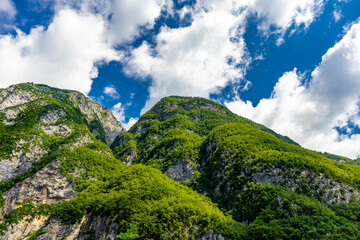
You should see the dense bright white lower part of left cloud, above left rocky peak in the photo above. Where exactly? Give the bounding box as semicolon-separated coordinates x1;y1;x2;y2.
0;9;118;93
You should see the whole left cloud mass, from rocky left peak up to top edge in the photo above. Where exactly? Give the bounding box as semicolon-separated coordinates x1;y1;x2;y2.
0;0;165;93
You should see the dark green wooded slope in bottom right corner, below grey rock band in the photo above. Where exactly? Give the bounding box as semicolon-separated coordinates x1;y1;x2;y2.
240;183;360;240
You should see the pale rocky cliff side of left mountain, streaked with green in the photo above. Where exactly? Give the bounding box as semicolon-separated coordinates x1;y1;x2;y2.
0;84;124;239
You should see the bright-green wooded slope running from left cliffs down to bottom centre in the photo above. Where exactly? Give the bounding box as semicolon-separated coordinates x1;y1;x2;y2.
4;137;242;239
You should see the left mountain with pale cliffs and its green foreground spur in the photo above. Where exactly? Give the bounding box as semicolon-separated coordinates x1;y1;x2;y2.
0;84;242;239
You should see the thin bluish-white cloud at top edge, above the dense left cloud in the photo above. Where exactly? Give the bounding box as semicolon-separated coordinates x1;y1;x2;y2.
43;0;167;45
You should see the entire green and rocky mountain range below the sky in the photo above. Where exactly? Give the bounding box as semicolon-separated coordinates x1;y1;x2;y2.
0;83;360;239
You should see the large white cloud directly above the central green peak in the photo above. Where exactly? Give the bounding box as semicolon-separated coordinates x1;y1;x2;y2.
126;0;322;112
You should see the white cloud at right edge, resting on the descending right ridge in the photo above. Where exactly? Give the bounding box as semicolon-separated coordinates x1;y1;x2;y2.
226;21;360;158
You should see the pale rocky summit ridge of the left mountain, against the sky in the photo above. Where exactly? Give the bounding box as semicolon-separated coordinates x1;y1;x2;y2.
0;83;125;145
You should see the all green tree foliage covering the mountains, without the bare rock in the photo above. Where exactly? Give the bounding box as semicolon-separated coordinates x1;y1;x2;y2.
0;84;360;239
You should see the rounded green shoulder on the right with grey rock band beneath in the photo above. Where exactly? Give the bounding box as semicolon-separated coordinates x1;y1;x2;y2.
197;124;360;218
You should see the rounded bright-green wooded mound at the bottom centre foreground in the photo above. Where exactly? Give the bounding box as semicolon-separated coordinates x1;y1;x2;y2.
53;165;242;239
